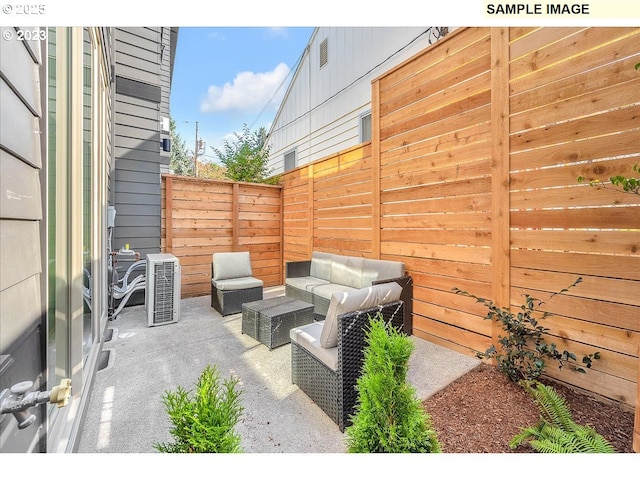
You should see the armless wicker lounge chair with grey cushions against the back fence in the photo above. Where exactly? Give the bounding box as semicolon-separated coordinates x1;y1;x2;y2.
211;252;264;317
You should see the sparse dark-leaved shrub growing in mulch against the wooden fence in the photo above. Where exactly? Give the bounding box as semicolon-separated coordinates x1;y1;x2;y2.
453;277;600;382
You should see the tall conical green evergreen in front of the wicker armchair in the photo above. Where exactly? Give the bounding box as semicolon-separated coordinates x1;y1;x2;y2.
345;314;440;453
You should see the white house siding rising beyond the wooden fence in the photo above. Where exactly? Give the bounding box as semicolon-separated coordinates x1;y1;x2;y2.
269;27;452;174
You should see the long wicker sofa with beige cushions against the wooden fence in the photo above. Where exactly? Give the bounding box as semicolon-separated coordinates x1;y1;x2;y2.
285;252;413;335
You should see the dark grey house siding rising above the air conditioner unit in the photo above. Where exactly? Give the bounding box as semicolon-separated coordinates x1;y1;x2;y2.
113;27;175;262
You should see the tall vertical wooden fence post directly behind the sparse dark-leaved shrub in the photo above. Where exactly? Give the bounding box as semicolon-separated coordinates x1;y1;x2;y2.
491;27;511;345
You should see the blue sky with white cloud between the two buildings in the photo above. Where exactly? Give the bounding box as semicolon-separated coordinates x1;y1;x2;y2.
170;26;313;162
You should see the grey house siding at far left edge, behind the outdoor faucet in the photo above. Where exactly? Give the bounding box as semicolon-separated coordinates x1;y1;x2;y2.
0;27;46;452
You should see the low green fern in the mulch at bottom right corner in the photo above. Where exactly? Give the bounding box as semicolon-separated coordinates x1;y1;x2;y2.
509;381;615;453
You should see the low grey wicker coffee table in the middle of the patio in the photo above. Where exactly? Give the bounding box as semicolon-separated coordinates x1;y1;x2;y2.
242;297;313;350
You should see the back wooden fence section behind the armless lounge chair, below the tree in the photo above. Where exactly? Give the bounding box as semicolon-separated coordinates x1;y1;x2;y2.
161;175;282;297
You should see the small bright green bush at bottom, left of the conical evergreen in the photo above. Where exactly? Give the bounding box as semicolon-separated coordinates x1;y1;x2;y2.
154;366;244;453
